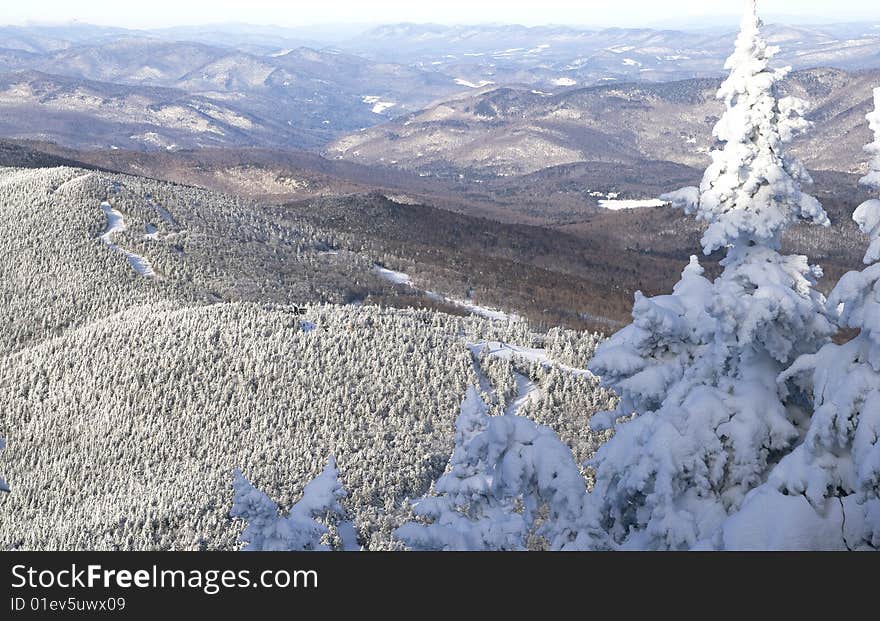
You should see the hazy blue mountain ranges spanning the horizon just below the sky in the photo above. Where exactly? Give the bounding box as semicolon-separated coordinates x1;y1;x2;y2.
0;23;880;153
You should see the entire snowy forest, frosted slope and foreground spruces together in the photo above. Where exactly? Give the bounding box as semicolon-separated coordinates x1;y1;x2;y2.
0;0;880;551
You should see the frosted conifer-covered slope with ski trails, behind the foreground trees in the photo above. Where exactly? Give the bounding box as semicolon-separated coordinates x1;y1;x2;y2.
0;163;613;549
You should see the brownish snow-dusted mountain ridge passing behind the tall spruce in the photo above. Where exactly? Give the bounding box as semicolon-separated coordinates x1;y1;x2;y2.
326;69;880;177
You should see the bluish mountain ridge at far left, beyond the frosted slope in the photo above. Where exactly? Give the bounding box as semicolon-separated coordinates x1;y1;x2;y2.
0;37;461;150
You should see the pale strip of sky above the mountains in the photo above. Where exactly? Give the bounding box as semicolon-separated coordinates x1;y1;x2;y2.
0;0;880;28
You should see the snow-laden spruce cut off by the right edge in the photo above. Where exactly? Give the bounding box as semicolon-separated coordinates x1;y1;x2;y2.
722;89;880;550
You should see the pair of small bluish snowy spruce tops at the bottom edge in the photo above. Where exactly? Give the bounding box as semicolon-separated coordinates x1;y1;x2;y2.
229;457;358;552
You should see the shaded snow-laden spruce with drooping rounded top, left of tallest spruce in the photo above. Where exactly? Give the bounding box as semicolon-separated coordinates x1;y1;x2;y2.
395;387;586;551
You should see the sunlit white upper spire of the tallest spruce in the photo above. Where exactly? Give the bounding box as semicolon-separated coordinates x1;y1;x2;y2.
684;0;830;255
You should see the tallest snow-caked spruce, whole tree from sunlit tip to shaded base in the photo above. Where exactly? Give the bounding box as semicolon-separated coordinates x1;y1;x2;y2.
578;1;834;549
